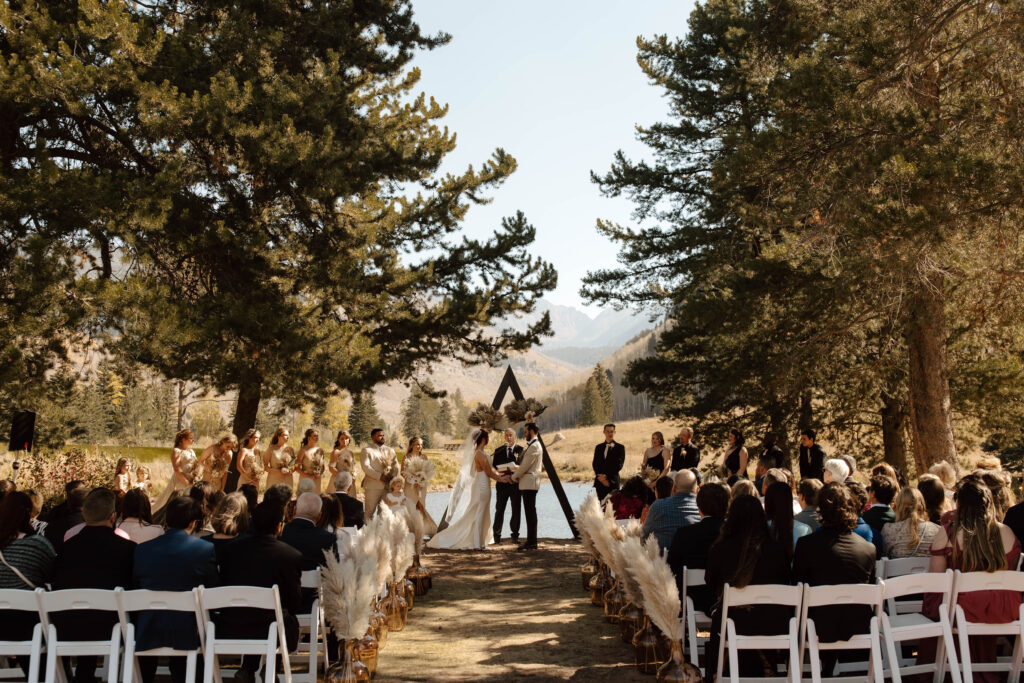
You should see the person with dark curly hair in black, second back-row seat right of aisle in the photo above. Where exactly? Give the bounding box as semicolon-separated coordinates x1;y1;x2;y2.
793;482;876;676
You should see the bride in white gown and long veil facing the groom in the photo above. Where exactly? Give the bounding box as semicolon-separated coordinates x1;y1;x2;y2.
427;429;510;550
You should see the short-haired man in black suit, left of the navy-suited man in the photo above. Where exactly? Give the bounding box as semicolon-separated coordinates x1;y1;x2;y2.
52;488;135;683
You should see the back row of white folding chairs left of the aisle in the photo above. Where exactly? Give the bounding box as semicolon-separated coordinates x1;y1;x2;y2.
0;586;305;683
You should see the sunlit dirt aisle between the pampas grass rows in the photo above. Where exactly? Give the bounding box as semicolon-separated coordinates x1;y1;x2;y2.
376;540;652;683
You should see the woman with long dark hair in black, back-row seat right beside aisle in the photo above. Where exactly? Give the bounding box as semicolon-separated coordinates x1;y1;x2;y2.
705;491;795;676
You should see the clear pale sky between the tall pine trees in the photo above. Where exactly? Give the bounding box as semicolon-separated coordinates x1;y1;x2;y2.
413;0;693;314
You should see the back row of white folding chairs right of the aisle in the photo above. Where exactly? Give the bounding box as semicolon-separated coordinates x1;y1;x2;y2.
704;569;1024;683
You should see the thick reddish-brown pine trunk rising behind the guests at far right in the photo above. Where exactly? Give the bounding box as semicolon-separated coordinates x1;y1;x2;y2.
905;286;958;472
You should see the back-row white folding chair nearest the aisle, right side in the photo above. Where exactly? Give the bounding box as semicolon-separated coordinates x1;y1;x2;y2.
715;584;804;683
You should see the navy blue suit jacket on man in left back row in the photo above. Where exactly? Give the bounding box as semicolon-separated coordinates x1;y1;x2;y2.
134;528;218;650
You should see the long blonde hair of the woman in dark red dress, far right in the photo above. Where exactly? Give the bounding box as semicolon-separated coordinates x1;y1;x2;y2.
949;479;1007;571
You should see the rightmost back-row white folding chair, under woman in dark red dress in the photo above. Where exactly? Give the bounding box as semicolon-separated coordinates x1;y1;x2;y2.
951;570;1024;683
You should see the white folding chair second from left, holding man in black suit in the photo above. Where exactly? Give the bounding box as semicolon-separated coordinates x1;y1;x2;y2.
36;588;121;683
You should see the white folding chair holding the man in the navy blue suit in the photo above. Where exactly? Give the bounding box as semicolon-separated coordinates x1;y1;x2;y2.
115;588;204;683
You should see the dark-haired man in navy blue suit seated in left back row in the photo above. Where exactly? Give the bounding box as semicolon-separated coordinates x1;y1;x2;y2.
132;497;218;683
